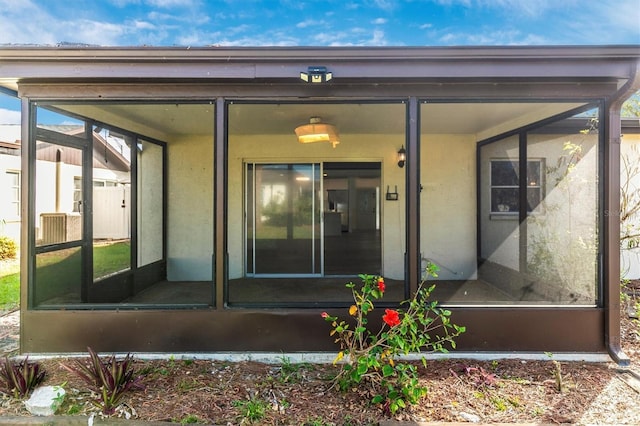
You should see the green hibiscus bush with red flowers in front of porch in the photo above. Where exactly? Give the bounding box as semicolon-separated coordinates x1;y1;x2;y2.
322;265;465;414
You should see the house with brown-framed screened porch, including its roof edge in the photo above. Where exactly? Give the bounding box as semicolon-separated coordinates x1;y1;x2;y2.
0;46;640;362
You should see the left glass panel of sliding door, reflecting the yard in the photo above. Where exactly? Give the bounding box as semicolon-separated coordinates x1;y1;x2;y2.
247;164;322;275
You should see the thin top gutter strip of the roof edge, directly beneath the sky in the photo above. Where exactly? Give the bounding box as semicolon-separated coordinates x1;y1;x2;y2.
0;45;640;62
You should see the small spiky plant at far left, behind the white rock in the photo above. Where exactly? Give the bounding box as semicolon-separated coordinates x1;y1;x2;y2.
0;357;45;398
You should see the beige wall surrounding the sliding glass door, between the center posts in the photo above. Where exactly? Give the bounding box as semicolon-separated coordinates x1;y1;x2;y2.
227;134;406;279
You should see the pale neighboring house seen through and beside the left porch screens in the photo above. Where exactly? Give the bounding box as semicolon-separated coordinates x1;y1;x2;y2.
0;125;131;244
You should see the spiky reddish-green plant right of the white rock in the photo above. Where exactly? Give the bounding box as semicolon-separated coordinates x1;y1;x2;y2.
65;348;142;415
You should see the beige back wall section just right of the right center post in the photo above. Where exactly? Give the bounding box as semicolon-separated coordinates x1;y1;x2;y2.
420;134;477;280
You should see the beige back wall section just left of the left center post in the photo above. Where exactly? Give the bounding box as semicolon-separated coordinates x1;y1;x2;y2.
167;135;214;281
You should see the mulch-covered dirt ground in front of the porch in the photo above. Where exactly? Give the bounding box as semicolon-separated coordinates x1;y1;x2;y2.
0;283;640;425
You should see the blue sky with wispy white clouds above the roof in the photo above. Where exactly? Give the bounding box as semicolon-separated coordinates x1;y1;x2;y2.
0;0;640;124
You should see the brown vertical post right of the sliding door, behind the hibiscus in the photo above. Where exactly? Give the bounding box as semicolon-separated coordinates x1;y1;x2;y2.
405;97;421;296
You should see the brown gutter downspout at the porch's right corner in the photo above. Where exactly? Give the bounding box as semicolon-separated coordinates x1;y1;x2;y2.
604;62;640;366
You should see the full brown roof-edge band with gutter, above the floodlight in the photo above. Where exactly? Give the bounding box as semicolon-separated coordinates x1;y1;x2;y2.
0;46;640;81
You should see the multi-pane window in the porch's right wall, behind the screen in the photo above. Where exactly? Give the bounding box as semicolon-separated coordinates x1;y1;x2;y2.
491;159;542;215
